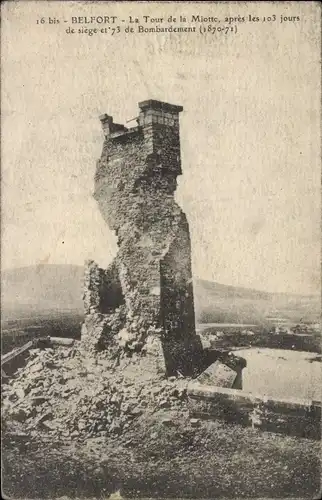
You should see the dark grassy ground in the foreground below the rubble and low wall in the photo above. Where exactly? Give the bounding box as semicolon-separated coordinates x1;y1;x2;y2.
3;413;320;499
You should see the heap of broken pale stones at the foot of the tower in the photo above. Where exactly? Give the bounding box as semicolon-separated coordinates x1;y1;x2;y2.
2;346;187;440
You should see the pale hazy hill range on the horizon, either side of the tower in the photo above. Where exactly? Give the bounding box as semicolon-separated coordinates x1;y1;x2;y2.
1;264;320;324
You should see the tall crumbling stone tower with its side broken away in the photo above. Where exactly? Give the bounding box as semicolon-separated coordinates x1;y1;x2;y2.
82;100;202;375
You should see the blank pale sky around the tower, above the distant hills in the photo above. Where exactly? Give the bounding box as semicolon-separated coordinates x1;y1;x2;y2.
2;2;321;293
